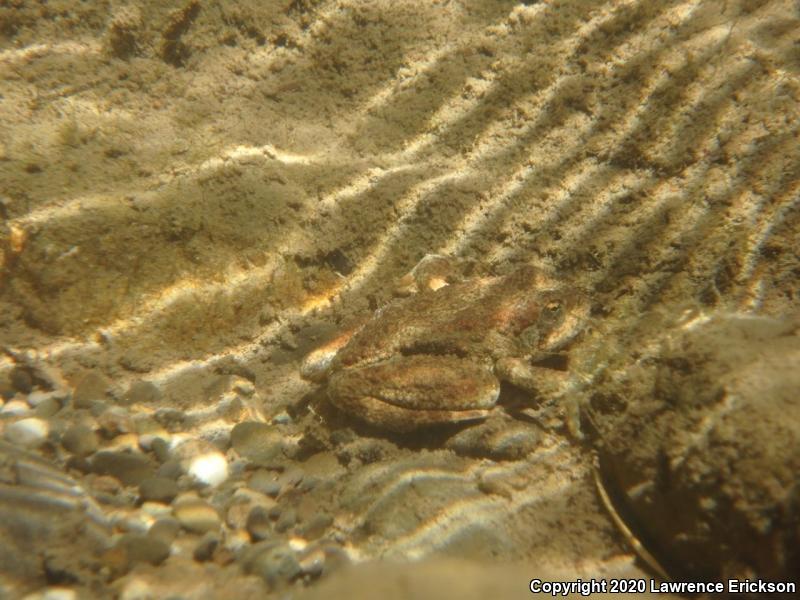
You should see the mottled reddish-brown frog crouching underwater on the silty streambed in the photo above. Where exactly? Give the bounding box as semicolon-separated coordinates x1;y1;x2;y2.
301;255;588;433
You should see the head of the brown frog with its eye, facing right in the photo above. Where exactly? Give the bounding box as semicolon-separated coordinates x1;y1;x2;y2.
519;290;589;352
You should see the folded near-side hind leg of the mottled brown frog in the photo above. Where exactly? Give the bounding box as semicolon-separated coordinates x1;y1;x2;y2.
328;355;500;432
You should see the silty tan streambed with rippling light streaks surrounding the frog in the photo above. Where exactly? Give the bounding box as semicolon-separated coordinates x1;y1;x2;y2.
0;0;800;597
